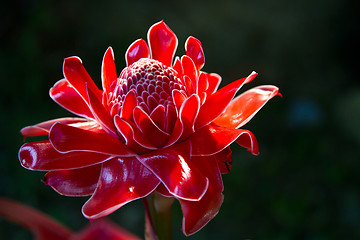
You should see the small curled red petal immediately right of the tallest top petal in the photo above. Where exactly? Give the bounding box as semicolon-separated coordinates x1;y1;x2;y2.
185;36;205;71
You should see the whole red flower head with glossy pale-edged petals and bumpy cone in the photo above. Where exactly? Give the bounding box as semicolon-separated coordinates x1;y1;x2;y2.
19;21;278;235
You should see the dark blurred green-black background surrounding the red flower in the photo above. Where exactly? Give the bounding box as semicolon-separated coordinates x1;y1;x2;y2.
0;0;360;240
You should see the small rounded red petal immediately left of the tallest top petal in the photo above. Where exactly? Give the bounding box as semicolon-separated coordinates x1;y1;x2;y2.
125;39;150;66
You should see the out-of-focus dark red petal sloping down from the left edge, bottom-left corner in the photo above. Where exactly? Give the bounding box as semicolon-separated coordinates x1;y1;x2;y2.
0;198;73;240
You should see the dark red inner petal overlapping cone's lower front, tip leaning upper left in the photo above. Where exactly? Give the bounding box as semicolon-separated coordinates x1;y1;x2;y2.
133;107;170;148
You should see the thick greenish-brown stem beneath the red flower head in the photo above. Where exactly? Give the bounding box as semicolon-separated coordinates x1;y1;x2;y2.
144;192;174;240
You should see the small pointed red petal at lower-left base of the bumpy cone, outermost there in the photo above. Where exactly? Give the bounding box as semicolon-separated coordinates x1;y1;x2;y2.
114;116;157;154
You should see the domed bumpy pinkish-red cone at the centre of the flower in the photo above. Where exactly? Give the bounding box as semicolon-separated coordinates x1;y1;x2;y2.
109;58;186;115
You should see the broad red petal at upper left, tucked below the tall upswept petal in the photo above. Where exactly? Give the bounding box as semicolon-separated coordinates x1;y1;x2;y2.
50;79;94;118
